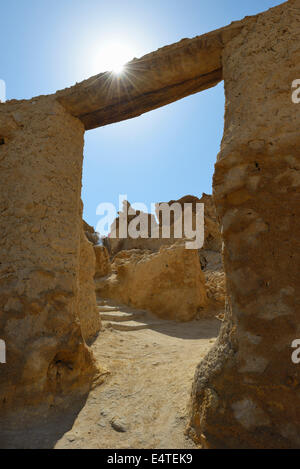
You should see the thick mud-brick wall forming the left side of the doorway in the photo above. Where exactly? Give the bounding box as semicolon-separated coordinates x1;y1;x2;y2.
0;97;95;412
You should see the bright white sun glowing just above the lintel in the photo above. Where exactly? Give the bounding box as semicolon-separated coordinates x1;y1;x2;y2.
98;42;134;75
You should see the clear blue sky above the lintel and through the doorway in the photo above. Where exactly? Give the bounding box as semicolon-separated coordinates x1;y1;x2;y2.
0;0;282;226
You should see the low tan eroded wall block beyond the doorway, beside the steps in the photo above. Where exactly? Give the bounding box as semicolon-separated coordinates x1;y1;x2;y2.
96;245;207;321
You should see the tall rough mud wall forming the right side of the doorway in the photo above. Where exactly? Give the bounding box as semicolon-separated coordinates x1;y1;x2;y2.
190;0;300;448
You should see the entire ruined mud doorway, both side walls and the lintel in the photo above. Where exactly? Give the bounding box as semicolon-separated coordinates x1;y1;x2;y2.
0;0;300;448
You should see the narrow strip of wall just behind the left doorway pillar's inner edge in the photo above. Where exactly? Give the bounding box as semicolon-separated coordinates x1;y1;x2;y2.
78;223;101;341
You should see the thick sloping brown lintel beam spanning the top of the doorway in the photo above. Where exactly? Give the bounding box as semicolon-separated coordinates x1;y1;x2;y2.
56;20;247;130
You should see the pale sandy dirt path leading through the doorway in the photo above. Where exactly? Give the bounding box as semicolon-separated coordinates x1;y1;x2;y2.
0;310;220;449
